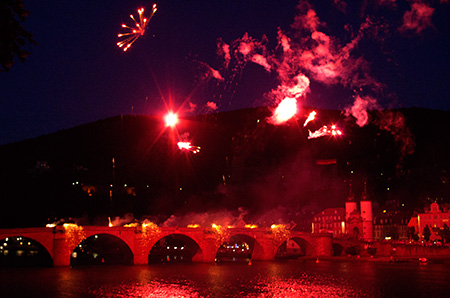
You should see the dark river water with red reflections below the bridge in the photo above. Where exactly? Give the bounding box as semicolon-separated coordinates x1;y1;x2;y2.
0;260;450;298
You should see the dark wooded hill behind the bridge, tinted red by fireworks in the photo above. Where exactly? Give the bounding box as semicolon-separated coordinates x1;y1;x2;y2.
0;108;450;227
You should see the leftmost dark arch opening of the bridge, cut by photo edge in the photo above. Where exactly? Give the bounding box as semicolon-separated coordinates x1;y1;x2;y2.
0;236;53;267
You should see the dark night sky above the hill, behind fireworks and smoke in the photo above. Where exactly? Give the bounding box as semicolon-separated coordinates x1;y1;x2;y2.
0;0;450;144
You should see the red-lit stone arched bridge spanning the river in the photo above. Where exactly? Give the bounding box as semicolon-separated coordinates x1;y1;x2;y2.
0;225;332;266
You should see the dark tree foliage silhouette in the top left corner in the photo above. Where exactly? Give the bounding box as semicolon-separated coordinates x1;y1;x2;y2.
0;0;37;72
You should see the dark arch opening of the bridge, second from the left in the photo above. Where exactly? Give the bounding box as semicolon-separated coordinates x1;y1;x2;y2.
70;233;134;266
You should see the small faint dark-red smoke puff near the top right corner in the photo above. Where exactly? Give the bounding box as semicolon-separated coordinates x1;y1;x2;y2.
400;2;434;33
